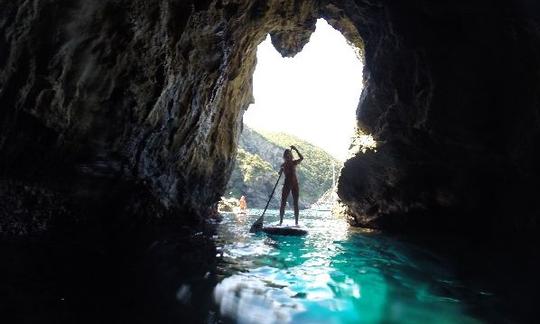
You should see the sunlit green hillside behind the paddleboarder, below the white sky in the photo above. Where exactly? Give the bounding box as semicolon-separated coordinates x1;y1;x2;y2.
226;124;340;208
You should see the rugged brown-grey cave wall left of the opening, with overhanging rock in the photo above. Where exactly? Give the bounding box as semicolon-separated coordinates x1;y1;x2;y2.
0;0;315;233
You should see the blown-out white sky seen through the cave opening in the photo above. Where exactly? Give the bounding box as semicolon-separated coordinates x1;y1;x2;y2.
244;19;362;160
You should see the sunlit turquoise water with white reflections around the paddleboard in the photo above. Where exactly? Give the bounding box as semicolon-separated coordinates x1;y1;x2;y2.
213;210;490;323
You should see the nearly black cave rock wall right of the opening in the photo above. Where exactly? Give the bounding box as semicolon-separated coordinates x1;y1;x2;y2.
339;1;540;239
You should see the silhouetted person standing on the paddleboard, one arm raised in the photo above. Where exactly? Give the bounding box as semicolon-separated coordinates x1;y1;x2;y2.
279;145;304;226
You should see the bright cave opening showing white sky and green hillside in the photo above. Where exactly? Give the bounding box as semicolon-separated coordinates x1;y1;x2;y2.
227;18;363;208
